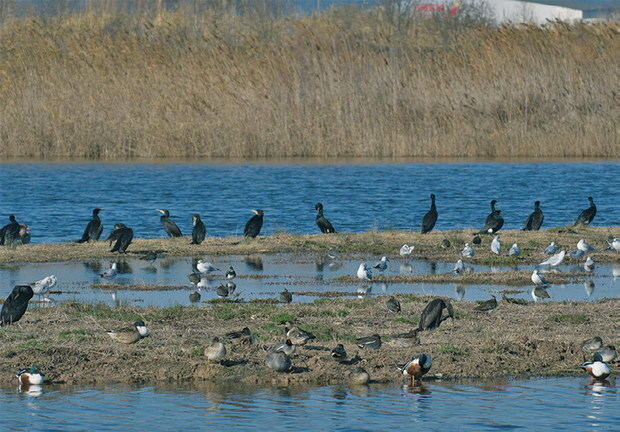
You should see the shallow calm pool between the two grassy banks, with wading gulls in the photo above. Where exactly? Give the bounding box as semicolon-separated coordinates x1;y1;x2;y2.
0;253;620;306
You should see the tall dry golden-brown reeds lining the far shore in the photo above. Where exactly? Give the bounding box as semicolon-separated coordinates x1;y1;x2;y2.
0;2;620;159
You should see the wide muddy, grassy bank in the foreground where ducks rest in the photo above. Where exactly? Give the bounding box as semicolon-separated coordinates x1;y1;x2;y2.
0;295;620;385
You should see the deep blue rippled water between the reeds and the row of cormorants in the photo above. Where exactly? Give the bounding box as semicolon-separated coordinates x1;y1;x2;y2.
0;162;620;243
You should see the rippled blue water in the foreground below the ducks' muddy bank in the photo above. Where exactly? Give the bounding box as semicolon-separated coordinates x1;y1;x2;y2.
0;377;620;432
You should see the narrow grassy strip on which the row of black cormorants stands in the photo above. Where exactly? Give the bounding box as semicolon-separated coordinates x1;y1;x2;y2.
0;227;620;264
